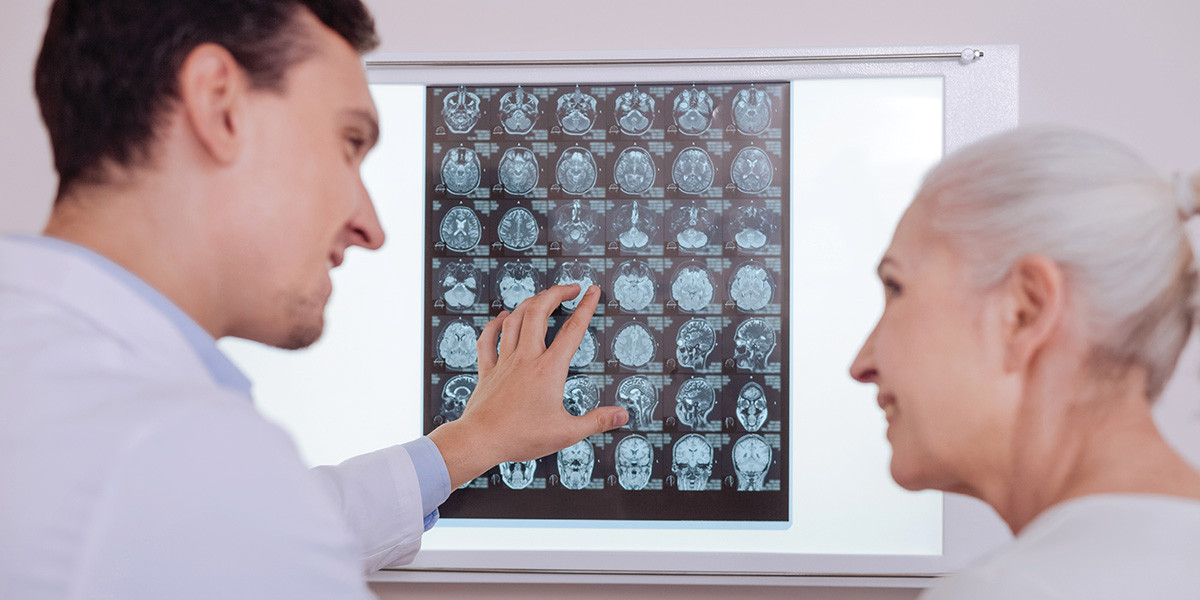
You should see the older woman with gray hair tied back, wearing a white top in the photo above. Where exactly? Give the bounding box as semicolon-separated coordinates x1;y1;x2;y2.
851;128;1200;599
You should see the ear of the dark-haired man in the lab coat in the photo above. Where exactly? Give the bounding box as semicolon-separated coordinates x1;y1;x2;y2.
179;43;247;164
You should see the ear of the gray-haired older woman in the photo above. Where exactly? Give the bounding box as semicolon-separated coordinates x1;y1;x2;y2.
1002;254;1067;371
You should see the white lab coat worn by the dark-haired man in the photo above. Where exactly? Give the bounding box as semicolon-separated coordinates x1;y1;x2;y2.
0;238;424;600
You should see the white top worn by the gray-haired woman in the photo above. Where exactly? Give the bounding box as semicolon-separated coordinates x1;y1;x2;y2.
920;494;1200;600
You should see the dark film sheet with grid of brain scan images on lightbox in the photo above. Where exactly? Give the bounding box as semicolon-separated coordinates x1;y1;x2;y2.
425;82;790;522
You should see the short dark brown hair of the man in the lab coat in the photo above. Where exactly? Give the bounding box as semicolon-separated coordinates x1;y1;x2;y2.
34;0;379;199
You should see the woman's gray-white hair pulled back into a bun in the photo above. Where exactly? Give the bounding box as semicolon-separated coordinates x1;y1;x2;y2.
918;127;1196;400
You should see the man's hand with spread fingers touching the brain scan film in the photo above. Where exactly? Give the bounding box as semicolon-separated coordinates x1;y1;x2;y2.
430;284;629;488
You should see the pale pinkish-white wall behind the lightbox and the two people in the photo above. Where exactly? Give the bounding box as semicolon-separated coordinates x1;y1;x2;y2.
0;0;1200;600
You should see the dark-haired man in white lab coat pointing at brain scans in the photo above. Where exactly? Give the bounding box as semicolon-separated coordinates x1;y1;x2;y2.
0;0;628;599
